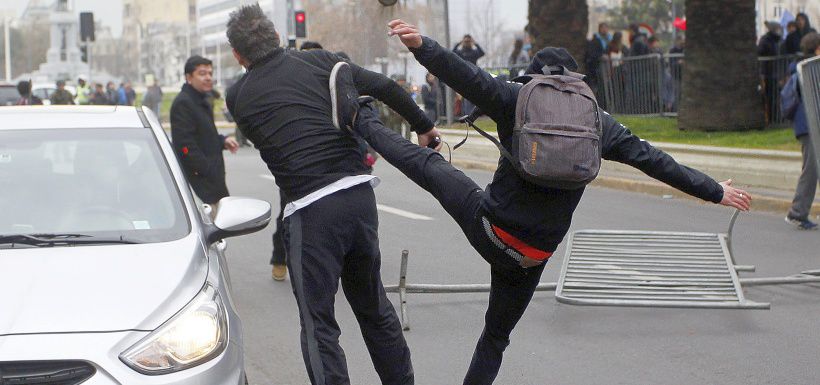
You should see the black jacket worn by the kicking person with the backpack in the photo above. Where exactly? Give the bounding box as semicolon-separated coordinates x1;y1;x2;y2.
411;37;723;251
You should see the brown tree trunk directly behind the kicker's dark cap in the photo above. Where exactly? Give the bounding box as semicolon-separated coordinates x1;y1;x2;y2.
527;0;589;70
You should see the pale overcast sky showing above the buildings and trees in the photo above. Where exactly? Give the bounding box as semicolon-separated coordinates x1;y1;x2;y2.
0;0;527;36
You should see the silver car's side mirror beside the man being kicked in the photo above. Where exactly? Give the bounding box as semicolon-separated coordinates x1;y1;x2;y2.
207;197;271;243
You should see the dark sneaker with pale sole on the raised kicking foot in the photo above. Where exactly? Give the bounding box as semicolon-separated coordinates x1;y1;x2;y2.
330;62;359;133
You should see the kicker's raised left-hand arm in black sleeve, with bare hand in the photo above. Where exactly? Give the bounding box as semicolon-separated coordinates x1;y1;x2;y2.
388;20;518;130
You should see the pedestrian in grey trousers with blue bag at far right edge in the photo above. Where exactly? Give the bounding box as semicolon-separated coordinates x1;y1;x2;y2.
786;32;820;230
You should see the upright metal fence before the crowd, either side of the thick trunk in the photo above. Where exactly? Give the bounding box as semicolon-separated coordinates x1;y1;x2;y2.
595;54;799;125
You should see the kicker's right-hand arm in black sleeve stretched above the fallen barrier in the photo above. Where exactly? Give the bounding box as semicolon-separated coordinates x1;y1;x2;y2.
602;113;752;211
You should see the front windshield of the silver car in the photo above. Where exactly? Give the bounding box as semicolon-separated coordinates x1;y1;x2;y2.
0;128;190;242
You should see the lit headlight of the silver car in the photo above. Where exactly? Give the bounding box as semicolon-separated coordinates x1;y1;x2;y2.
120;284;228;375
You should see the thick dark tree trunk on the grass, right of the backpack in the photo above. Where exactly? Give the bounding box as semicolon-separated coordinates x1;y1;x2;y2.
678;0;764;131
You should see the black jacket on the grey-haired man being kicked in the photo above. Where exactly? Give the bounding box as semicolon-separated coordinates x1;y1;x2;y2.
226;48;433;201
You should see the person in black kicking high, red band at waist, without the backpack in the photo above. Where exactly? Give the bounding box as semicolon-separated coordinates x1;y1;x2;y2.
346;20;751;385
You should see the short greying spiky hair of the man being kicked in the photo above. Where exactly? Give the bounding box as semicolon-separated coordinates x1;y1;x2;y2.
226;3;279;64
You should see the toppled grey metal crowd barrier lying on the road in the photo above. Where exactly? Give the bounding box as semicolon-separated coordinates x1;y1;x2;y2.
384;210;820;330
